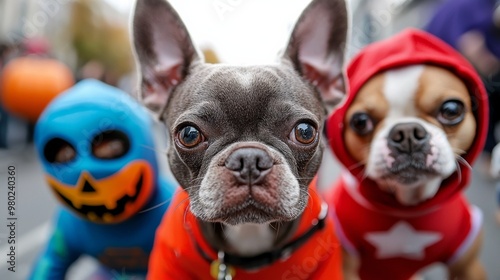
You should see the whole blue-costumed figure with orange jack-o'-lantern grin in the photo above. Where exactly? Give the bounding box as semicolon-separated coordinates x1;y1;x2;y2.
31;80;176;280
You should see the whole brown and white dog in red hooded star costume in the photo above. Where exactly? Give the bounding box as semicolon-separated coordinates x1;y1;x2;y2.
327;29;488;279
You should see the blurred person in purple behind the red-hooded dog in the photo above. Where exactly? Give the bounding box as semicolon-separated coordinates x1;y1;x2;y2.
425;0;500;167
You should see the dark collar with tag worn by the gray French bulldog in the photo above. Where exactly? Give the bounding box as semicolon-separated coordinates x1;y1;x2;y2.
195;202;328;280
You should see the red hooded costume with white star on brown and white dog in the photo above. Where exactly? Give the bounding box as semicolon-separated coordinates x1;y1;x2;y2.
327;30;488;279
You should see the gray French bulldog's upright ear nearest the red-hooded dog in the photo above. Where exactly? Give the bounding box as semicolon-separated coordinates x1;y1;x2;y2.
284;0;348;111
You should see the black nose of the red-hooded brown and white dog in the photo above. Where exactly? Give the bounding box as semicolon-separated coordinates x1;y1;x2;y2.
388;123;430;153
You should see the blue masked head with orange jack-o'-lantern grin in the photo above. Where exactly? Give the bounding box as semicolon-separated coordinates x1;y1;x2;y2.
34;80;158;223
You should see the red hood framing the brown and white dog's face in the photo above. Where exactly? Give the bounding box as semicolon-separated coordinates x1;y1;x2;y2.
326;29;488;209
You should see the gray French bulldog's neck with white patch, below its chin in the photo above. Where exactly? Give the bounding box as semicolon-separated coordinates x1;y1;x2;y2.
198;218;300;257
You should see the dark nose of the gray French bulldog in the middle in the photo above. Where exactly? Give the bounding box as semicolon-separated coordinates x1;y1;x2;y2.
225;148;273;185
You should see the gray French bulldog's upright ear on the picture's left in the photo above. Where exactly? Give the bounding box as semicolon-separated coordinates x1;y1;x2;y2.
132;0;200;114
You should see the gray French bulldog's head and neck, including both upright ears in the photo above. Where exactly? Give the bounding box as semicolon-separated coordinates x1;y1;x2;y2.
133;0;348;276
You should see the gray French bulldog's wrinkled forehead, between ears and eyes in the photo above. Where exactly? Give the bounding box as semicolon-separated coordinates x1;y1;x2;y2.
166;64;324;126
